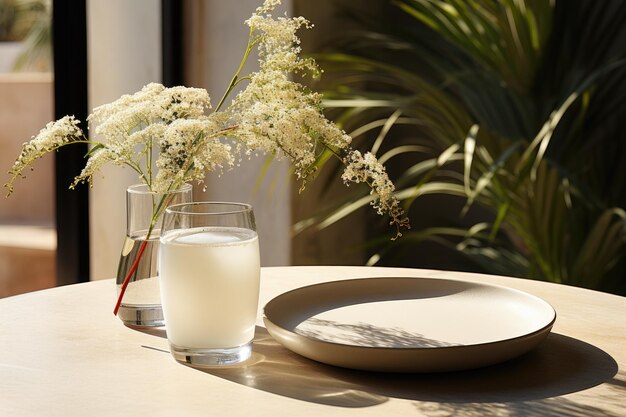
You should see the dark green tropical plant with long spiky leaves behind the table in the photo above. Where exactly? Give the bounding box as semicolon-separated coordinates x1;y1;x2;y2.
295;0;626;293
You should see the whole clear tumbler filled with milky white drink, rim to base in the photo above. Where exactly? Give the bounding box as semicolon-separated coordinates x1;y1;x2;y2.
159;202;261;366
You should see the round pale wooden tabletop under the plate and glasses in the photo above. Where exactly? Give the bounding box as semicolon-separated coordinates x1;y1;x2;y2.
0;267;626;417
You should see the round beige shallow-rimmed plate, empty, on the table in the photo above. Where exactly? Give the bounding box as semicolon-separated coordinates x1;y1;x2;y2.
263;278;556;372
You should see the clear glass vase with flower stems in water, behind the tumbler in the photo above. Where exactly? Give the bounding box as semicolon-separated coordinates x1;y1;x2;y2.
117;184;192;327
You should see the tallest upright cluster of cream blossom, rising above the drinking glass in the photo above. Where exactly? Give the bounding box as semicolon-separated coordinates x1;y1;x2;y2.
226;2;351;180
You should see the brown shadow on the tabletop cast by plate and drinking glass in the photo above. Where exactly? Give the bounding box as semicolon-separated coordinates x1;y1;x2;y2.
197;327;618;406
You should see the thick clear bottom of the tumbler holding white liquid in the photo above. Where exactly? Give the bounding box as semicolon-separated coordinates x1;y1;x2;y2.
170;342;252;368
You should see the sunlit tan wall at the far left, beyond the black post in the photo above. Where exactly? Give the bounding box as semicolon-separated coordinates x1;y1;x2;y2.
0;73;56;297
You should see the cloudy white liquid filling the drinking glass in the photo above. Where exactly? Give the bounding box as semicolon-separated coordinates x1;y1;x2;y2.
159;227;260;349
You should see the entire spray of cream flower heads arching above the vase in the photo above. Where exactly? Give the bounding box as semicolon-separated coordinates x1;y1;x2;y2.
6;0;408;233
